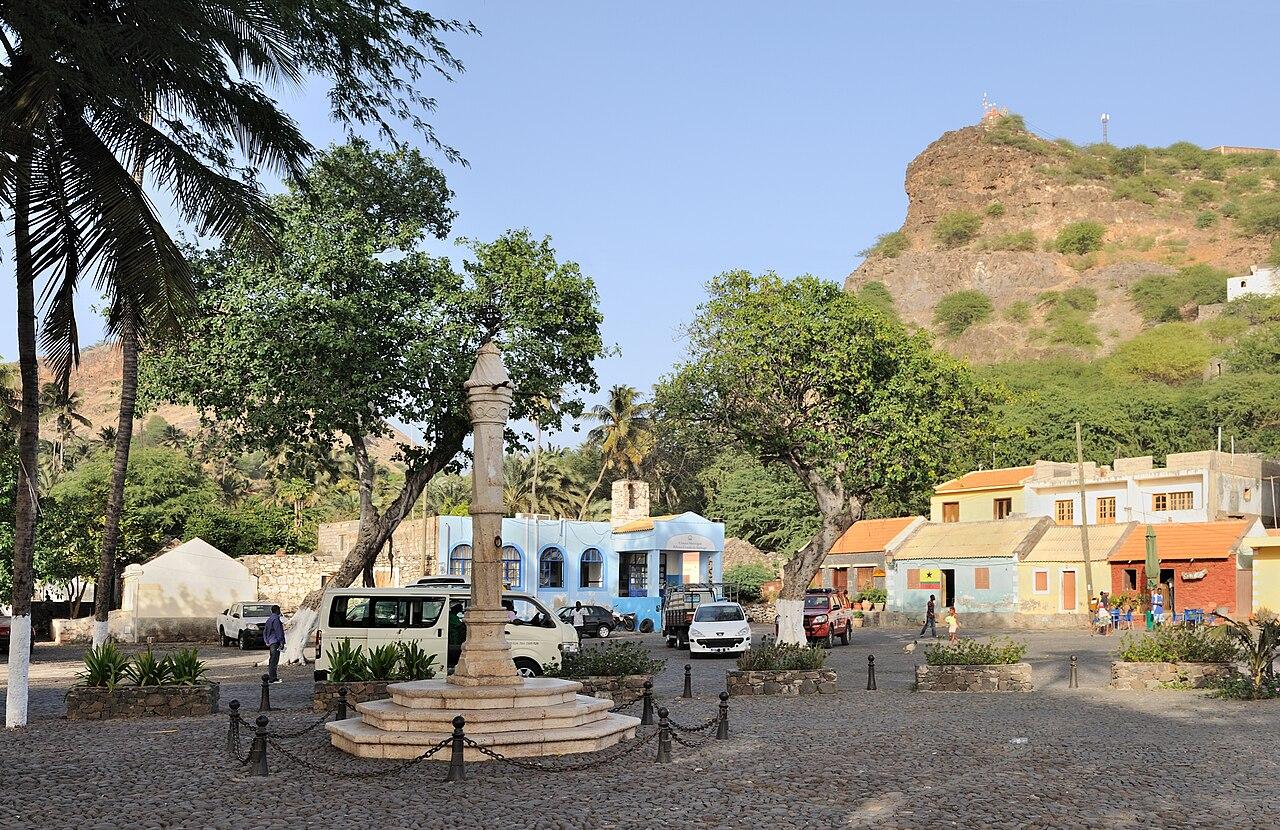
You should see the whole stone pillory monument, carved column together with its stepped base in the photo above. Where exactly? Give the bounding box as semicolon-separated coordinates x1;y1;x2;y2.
326;343;640;761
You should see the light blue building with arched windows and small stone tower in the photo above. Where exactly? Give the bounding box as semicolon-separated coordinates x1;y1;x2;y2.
429;482;724;625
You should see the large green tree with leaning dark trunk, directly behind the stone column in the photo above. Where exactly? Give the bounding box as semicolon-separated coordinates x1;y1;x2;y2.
146;143;603;644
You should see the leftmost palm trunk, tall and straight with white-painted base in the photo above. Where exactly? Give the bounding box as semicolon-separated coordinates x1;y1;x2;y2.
4;138;40;728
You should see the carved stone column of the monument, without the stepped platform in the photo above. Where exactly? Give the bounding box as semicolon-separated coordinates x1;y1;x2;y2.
449;342;520;685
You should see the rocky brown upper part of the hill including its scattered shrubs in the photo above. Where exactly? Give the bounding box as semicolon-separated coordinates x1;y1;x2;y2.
846;117;1280;361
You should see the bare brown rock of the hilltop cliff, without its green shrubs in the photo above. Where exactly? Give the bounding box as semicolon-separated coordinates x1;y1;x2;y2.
845;127;1270;361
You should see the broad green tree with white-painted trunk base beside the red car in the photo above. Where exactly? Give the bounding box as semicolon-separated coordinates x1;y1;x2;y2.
663;272;993;643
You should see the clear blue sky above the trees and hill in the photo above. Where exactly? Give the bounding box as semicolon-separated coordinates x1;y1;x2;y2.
0;0;1280;443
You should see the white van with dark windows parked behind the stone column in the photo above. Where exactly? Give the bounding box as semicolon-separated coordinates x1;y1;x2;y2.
315;579;579;680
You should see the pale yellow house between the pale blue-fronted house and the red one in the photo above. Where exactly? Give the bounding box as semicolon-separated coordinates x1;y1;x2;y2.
1018;523;1137;624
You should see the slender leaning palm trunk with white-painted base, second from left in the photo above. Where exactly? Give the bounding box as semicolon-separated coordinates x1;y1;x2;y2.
93;311;138;646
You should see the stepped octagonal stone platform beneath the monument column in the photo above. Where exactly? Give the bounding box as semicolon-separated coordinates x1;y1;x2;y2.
325;678;640;761
